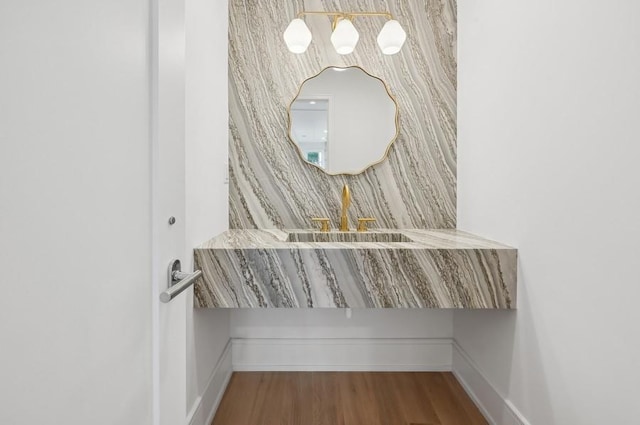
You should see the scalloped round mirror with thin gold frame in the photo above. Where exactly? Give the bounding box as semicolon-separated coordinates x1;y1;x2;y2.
289;66;398;175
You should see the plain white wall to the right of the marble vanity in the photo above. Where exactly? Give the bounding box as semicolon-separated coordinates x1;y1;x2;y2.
454;0;640;425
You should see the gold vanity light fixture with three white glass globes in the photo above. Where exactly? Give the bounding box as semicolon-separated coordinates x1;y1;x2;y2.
284;12;407;55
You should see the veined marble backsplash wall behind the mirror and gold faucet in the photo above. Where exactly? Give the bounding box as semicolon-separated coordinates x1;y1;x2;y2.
229;0;457;229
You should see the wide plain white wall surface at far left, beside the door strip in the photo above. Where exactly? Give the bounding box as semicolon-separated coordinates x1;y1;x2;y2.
0;0;151;425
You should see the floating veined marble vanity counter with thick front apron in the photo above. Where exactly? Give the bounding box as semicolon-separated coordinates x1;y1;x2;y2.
194;229;517;309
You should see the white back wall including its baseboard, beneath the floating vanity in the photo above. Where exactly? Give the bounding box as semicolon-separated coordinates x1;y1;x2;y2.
231;309;453;370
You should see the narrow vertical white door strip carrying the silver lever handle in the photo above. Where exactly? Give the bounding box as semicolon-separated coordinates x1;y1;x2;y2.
151;0;187;425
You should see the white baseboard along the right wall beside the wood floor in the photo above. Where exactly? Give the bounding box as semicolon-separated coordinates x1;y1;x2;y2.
452;340;530;425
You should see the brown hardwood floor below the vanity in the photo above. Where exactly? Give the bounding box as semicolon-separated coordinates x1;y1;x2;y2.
212;372;487;425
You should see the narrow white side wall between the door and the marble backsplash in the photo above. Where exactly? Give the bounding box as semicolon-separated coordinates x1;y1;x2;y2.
184;0;229;425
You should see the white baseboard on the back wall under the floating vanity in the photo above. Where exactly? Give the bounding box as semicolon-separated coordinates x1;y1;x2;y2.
232;338;452;371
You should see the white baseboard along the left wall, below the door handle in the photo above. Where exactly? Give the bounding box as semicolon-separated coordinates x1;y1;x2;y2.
186;339;233;425
